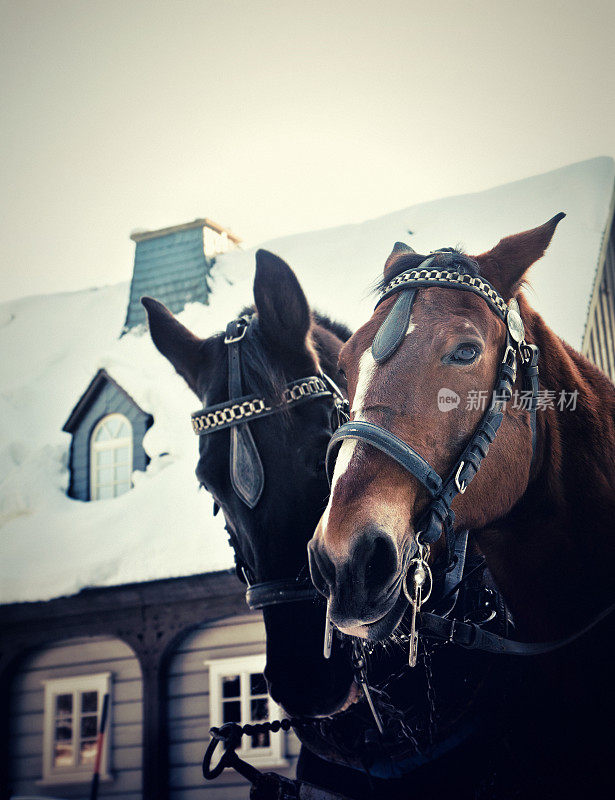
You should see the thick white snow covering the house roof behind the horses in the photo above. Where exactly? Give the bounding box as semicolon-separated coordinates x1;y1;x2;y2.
0;158;615;602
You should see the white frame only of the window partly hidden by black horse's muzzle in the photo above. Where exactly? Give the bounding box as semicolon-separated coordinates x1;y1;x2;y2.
204;653;288;767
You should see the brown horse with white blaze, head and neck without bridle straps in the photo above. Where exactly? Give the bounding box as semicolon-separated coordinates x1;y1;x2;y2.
310;214;615;796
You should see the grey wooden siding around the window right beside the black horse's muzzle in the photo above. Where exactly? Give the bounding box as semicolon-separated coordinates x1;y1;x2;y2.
168;614;300;800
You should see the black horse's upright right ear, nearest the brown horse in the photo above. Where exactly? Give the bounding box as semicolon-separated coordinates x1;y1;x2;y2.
254;250;312;350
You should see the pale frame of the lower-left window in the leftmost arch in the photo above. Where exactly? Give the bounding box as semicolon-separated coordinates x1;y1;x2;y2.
38;672;112;785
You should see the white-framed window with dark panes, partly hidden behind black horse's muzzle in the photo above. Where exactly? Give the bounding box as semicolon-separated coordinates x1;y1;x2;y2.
205;655;286;766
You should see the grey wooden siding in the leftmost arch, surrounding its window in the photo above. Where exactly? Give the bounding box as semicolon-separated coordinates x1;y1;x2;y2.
9;636;142;800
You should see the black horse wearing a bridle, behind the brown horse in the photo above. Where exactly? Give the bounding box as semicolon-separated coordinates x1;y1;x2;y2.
142;250;524;798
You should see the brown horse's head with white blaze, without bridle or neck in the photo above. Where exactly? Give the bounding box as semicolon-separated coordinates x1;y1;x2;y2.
310;214;564;640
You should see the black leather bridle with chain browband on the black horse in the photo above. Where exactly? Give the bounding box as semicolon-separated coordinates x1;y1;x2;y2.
191;316;348;610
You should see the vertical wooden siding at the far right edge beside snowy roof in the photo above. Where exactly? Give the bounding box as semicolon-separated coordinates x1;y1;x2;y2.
583;219;615;383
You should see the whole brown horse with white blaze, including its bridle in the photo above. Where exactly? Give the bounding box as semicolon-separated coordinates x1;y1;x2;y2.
309;214;615;797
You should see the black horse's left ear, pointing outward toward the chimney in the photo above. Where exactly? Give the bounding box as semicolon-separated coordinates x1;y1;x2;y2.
141;297;203;395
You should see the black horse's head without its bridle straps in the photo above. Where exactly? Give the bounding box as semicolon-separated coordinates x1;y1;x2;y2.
143;250;353;716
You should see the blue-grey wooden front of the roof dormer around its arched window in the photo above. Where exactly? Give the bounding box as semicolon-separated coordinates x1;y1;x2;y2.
68;381;152;500
